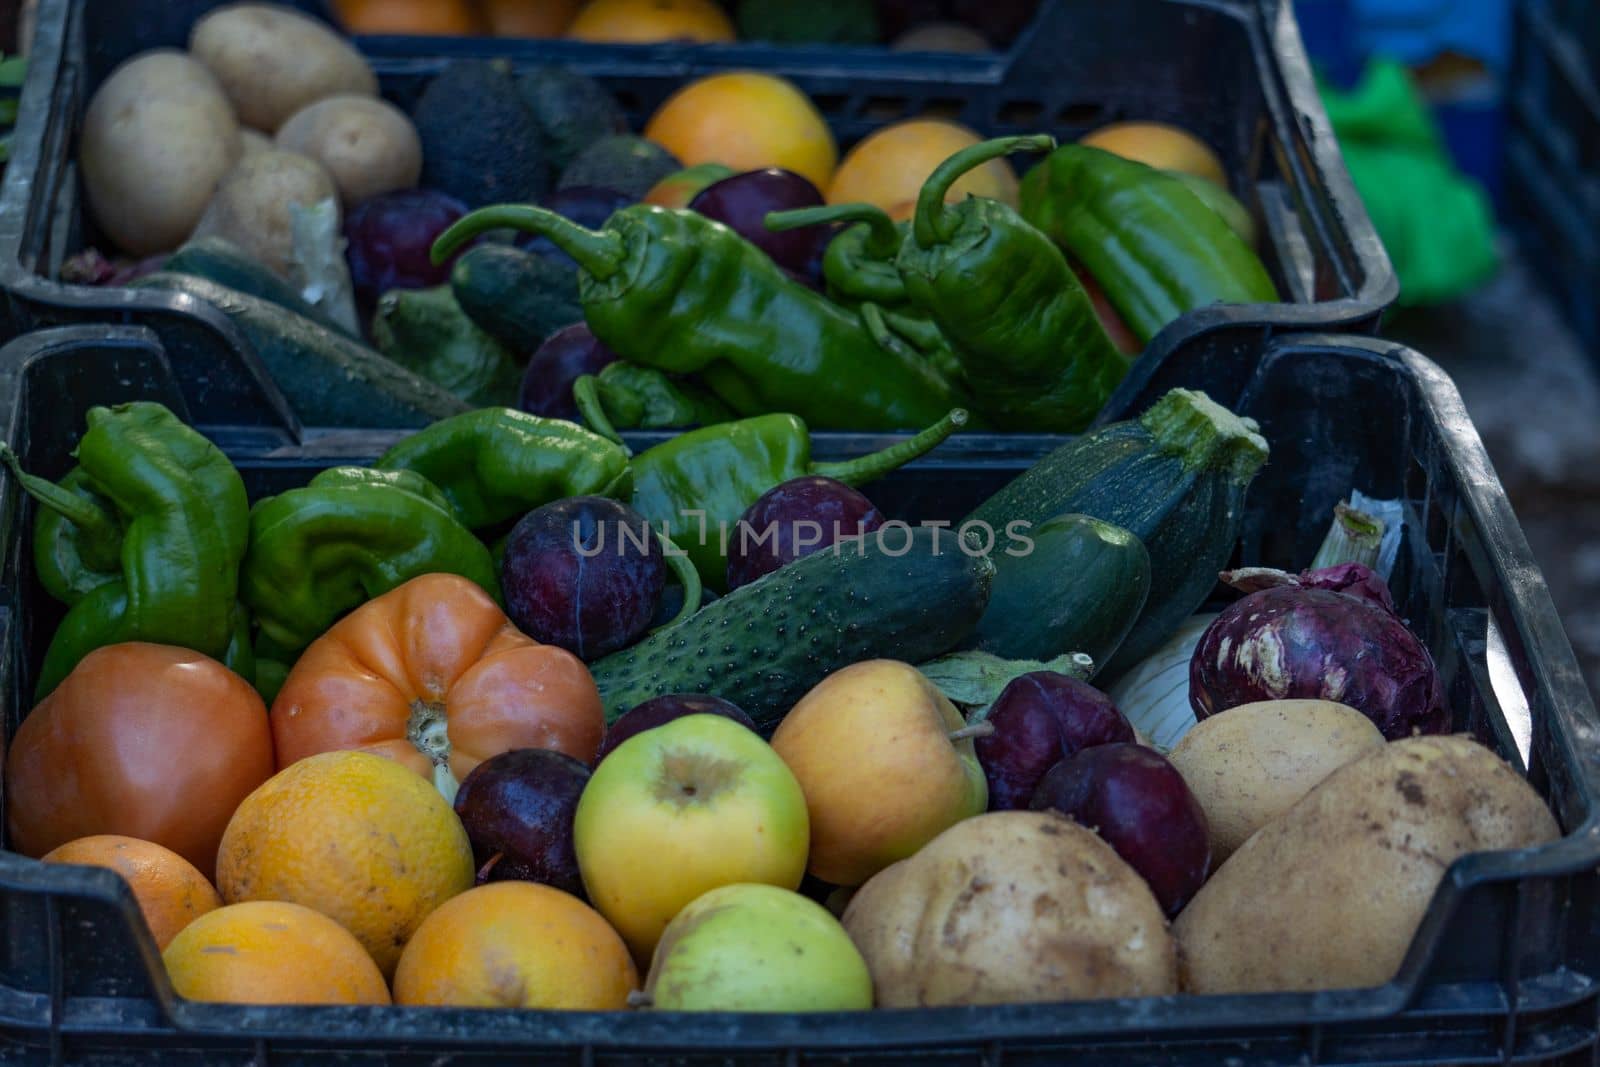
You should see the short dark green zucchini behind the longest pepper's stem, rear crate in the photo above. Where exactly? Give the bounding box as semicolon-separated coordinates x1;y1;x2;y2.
450;245;584;350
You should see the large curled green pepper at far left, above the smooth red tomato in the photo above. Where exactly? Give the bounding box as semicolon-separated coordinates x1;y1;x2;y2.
0;402;250;697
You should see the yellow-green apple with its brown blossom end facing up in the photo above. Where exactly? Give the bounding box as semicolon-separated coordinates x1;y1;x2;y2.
573;715;810;963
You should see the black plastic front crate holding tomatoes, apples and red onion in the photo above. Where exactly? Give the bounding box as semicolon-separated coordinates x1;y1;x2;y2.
0;328;1600;1067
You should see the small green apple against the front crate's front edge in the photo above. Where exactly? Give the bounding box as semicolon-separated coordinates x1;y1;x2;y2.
629;883;872;1011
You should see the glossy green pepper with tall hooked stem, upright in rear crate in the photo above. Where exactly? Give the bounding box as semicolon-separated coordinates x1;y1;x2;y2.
898;136;1128;434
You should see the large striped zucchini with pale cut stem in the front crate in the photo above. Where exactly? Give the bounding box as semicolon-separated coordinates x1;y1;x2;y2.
968;389;1267;681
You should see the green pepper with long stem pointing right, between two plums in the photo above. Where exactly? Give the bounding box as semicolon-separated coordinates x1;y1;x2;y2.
632;408;966;590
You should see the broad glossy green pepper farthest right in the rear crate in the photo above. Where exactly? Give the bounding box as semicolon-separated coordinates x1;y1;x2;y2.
1021;144;1278;344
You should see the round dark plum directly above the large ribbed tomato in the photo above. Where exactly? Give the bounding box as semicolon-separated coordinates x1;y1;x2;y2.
501;496;667;661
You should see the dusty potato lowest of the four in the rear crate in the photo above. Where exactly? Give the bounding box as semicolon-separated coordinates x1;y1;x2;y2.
194;149;339;277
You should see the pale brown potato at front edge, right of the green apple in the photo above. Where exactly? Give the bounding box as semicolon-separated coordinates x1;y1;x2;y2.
843;811;1178;1008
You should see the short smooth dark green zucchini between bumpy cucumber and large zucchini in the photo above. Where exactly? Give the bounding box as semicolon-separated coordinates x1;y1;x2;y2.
976;514;1150;677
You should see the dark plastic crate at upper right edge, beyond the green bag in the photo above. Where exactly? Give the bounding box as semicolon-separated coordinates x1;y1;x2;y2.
1506;0;1600;360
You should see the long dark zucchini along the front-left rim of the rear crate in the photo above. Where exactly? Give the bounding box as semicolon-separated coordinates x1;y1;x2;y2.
133;270;467;429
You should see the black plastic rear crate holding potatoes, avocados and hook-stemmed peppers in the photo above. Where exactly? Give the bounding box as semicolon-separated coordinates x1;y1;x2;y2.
0;0;1398;432
